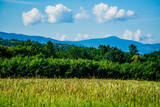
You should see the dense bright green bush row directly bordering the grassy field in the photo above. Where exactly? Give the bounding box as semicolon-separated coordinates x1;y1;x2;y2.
0;55;160;80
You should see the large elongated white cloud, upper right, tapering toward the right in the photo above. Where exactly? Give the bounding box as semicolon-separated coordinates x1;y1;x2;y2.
93;3;134;23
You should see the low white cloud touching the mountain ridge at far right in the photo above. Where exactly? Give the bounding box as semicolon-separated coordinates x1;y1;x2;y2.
122;29;154;43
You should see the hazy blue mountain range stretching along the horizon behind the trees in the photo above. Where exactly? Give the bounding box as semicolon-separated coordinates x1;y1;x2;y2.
0;32;160;54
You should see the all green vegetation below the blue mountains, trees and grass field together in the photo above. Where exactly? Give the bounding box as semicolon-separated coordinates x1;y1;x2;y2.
0;39;160;107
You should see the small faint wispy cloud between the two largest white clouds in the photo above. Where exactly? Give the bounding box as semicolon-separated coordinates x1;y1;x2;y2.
75;7;89;19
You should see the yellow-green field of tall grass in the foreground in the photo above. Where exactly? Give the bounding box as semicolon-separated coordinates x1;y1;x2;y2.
0;79;160;107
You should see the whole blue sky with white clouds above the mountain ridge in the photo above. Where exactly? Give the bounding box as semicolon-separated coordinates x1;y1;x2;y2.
0;0;160;44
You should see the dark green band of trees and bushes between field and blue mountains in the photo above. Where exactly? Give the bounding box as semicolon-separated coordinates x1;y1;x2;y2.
0;38;160;81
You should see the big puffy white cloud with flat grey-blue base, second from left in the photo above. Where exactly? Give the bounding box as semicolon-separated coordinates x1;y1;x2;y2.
45;4;73;23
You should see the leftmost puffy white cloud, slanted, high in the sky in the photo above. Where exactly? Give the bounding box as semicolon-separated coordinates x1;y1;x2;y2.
22;8;44;26
